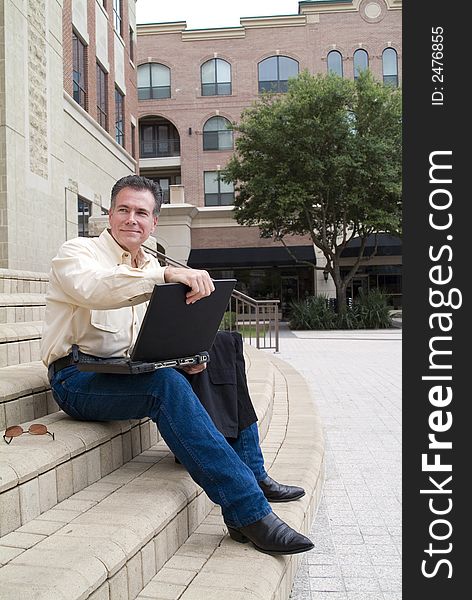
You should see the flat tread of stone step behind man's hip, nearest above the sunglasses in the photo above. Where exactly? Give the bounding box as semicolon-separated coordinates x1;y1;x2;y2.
0;360;50;402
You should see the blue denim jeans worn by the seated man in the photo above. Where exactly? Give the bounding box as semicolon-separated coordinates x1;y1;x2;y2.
51;365;271;528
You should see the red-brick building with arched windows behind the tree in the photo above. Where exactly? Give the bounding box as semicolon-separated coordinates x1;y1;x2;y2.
137;0;402;304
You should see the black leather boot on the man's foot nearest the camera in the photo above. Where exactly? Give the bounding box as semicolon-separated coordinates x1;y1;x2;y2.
227;512;314;554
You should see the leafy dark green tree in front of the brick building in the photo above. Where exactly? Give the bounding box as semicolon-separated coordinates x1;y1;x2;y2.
223;72;402;312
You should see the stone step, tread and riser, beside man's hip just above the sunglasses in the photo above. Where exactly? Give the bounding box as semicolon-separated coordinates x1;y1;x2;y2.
0;361;59;430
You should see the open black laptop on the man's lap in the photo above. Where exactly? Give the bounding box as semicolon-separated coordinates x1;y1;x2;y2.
77;279;236;375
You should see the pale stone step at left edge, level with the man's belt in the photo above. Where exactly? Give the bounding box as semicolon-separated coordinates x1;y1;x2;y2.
0;321;43;368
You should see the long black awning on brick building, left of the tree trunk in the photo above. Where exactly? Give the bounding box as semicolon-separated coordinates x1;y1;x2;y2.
188;246;316;269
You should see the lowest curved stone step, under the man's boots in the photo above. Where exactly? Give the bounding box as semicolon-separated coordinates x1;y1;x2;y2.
138;357;324;600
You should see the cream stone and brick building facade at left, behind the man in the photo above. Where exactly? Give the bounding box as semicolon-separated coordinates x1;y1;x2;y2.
0;0;138;271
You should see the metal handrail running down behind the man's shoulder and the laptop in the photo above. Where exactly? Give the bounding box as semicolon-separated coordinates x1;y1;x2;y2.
144;245;280;352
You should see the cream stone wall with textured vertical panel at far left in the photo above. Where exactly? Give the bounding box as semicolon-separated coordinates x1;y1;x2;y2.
0;0;64;271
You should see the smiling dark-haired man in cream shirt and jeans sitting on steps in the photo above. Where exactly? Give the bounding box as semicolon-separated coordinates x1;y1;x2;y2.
42;175;313;554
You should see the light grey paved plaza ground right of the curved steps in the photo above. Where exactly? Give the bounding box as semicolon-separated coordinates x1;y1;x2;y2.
272;327;402;600
